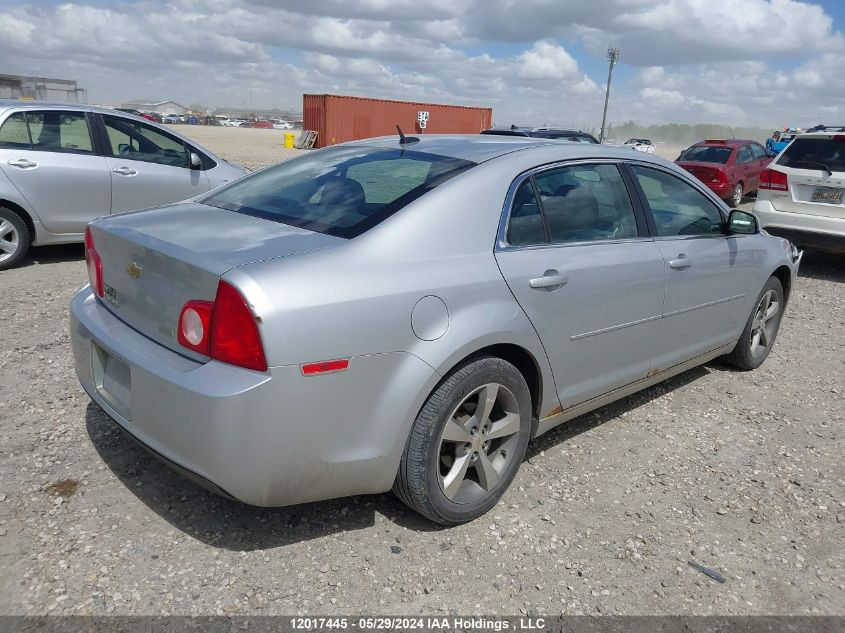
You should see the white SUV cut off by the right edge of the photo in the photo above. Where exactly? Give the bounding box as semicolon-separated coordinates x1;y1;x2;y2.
754;126;845;253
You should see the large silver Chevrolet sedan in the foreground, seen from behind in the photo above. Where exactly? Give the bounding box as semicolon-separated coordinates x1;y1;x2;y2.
71;135;800;524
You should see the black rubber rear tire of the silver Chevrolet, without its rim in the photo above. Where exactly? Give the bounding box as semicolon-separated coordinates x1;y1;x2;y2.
393;356;532;525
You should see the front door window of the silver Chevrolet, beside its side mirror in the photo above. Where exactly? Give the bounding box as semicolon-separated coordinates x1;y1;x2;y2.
631;165;722;237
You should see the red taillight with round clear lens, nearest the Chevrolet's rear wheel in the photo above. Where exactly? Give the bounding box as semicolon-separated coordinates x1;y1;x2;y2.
176;281;267;371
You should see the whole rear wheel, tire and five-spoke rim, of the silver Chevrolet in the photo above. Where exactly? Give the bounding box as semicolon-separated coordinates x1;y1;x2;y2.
393;356;531;525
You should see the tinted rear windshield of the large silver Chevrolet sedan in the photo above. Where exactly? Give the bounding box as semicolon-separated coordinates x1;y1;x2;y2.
200;147;475;238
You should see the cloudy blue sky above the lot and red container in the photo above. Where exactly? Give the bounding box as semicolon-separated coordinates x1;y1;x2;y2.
0;0;845;129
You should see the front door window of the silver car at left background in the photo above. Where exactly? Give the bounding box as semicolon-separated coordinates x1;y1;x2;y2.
103;115;191;168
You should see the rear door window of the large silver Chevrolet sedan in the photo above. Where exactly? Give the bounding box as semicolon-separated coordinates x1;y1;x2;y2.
534;165;638;244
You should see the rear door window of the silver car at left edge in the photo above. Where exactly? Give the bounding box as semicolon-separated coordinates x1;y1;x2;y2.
10;110;94;154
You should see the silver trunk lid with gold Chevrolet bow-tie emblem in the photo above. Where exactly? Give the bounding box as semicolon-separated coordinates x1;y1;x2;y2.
91;203;346;360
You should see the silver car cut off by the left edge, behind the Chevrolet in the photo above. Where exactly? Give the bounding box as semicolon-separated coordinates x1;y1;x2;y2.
0;100;247;270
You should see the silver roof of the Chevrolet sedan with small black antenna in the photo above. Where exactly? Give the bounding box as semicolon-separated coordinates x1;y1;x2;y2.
335;134;671;164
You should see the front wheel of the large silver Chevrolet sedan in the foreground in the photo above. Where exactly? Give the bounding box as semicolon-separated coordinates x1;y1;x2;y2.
724;277;784;370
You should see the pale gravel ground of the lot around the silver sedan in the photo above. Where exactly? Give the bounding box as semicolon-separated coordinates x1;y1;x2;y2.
0;130;845;615
